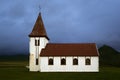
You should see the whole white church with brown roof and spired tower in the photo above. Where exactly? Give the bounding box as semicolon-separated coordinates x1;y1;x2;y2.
29;13;99;72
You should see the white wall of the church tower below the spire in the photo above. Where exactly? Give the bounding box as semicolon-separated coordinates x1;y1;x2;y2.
29;37;48;71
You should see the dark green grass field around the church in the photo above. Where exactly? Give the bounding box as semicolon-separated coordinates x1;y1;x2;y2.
0;61;120;80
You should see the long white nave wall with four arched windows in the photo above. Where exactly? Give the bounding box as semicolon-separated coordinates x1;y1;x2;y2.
40;57;99;72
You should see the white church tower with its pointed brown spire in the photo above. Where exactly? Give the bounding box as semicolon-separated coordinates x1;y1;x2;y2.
29;13;49;71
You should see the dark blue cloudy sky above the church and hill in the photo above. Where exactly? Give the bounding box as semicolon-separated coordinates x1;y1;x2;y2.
0;0;120;54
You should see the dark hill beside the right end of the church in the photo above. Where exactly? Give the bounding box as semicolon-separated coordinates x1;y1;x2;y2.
99;45;120;66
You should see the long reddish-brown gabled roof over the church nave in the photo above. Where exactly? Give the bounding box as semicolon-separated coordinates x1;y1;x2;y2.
40;43;98;56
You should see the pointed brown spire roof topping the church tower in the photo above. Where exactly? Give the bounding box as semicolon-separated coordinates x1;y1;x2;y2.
29;13;49;40
